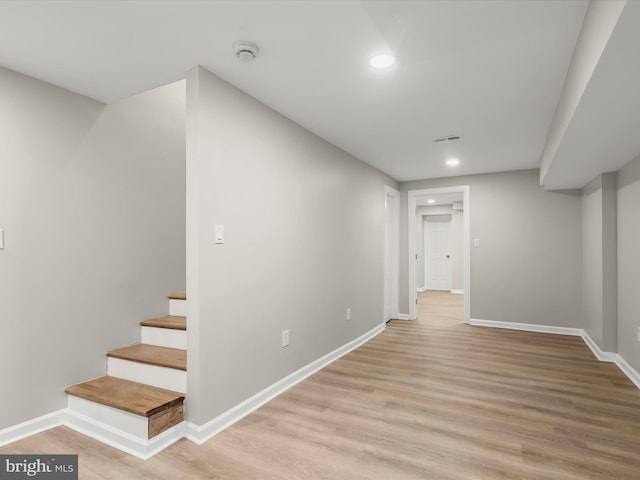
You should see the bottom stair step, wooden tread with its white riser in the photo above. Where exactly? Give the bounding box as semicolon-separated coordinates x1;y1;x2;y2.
65;376;184;438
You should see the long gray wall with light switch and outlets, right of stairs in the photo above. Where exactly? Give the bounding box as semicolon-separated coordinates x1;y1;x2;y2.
182;68;398;425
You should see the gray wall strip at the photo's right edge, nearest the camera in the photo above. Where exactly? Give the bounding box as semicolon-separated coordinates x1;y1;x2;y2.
617;158;640;372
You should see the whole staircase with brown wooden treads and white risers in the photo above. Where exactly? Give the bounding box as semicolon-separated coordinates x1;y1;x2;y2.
65;293;187;459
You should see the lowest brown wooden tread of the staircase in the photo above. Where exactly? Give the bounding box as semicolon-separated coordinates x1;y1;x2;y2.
65;377;184;417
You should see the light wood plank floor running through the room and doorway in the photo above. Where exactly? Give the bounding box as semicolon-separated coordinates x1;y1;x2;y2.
0;292;640;480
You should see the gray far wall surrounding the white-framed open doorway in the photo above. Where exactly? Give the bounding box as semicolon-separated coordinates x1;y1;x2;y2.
400;170;582;327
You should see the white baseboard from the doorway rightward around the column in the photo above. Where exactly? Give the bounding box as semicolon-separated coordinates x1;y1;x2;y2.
469;318;640;389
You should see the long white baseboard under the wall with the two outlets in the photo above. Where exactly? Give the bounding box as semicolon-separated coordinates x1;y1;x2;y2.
186;323;386;445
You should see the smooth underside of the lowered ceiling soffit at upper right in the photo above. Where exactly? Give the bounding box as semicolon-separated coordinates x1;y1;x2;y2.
544;0;640;189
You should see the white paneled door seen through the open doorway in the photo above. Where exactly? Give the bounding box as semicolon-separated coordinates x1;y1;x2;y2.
424;215;451;291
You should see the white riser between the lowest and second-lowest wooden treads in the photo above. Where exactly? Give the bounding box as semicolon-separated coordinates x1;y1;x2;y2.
107;357;187;393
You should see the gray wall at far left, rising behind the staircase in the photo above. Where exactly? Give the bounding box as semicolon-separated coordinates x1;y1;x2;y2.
0;69;185;428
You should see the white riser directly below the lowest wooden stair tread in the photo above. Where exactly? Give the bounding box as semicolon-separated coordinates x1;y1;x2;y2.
67;395;149;441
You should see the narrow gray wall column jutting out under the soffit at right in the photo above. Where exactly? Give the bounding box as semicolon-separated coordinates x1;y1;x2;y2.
582;173;617;352
